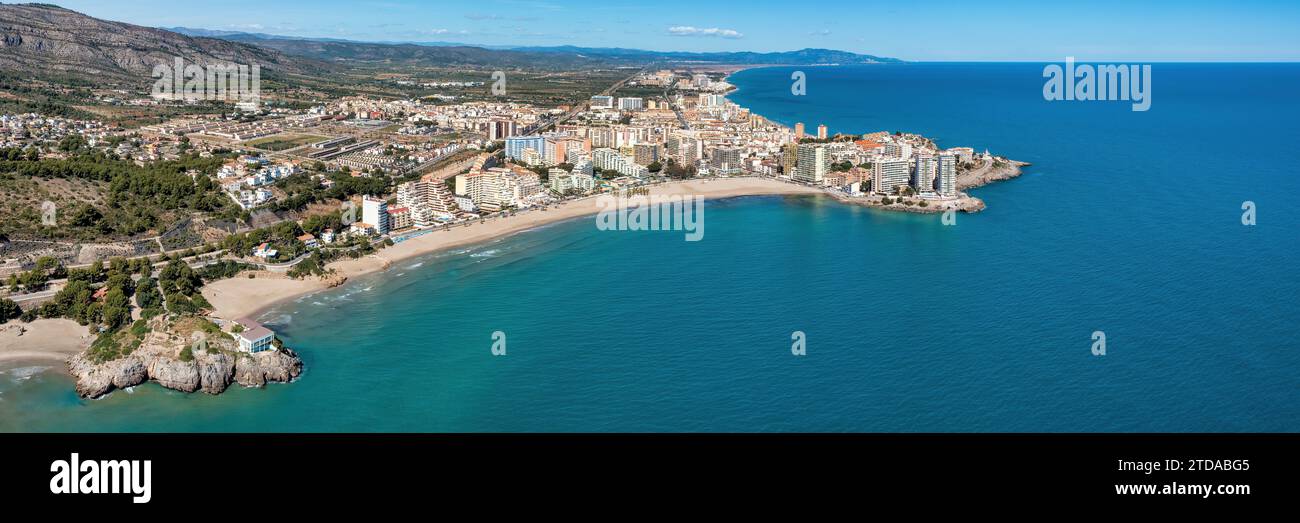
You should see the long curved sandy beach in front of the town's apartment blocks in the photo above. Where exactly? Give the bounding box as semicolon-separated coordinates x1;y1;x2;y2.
203;178;823;319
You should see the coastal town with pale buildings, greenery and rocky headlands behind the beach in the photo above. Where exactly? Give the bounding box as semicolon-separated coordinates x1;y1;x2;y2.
0;68;1026;397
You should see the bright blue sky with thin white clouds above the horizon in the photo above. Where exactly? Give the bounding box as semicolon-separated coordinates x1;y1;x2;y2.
56;0;1300;61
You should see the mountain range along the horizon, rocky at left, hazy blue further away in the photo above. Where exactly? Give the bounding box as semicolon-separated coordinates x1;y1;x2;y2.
0;4;900;83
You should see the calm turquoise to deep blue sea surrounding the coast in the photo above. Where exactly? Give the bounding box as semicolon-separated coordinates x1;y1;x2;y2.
0;64;1300;432
